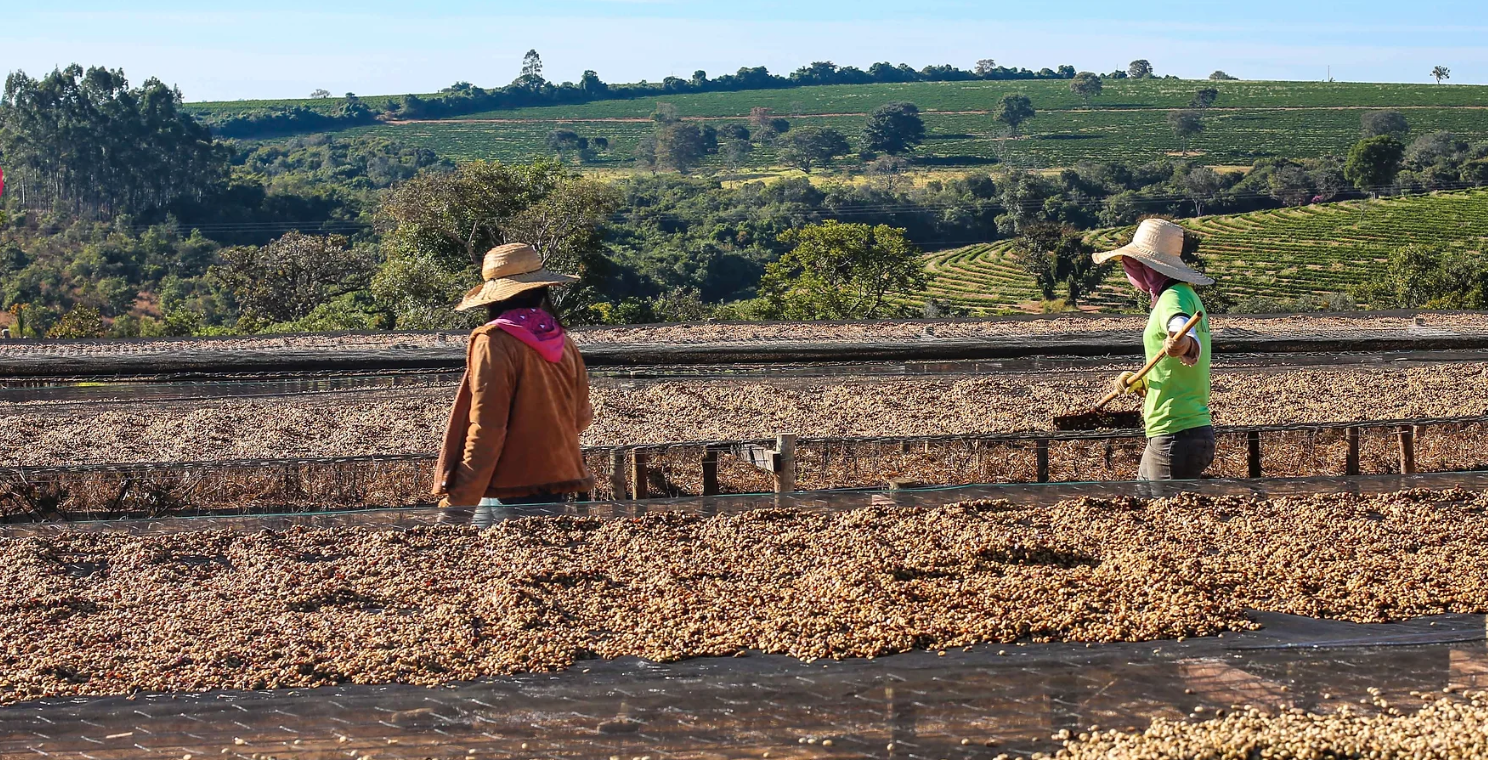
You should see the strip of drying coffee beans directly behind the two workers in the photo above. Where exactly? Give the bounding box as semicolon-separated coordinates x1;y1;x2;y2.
0;363;1488;466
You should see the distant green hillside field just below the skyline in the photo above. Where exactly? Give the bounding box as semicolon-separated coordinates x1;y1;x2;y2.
203;79;1488;171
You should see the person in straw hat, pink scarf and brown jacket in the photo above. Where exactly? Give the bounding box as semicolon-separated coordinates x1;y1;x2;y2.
434;242;594;525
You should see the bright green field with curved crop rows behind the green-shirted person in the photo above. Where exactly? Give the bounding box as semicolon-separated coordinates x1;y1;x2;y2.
927;190;1488;314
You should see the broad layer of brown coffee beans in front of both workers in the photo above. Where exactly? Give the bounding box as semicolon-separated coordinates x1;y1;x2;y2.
0;491;1488;702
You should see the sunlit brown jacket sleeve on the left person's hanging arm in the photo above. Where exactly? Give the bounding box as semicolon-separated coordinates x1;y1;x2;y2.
448;335;516;506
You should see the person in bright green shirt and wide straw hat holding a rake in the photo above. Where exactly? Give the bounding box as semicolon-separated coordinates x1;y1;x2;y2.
1095;219;1214;480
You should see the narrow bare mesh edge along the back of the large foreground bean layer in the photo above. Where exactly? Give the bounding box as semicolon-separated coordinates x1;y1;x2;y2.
11;471;1488;537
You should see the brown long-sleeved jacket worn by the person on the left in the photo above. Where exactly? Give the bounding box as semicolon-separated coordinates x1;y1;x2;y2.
434;324;594;507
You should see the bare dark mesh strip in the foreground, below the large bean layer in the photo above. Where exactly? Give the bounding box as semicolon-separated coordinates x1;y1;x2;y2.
0;613;1488;760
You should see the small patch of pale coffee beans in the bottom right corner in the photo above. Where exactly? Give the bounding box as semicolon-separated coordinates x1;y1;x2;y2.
1034;693;1488;760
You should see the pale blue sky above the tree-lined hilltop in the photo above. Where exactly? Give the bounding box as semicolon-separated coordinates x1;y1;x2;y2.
0;0;1488;100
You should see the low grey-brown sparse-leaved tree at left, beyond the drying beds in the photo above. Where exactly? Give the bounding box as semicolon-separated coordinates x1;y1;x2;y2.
208;232;376;323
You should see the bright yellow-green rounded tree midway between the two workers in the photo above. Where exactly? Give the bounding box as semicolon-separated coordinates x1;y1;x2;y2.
760;220;927;320
